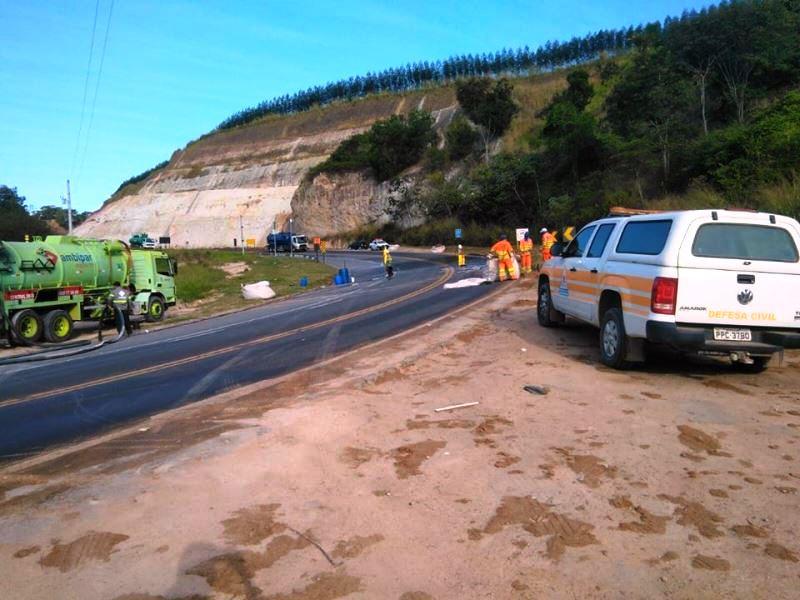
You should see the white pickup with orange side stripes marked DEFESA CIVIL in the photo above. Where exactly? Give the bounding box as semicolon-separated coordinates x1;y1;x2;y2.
537;210;800;371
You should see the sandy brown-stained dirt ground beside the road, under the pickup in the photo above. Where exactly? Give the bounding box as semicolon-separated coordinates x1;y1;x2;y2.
0;282;800;600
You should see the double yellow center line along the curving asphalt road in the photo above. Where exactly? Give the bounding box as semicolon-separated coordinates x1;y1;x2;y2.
0;259;454;408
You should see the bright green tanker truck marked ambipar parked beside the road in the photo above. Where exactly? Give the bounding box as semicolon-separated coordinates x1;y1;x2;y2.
0;236;178;344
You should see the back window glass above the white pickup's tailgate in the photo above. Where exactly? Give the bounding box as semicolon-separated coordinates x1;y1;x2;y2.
692;223;798;262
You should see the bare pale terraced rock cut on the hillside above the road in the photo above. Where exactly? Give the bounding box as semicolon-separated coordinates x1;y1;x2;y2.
76;87;456;247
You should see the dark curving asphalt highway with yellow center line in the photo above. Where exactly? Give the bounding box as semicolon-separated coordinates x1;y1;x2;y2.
0;253;492;461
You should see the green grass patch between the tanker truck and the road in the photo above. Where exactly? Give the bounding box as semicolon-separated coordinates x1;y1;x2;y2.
169;250;336;322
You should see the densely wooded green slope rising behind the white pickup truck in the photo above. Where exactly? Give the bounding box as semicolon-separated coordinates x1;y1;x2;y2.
318;0;800;243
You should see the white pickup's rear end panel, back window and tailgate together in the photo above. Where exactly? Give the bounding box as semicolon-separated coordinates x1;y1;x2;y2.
675;216;800;328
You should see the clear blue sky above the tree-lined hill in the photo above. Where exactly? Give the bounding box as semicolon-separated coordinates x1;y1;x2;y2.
0;0;708;210
